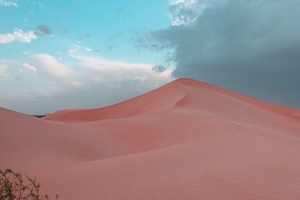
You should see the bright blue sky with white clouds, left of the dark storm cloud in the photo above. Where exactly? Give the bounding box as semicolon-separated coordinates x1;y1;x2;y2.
0;0;175;113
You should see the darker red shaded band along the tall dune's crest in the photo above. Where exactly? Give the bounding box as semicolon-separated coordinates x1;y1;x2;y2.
45;78;300;121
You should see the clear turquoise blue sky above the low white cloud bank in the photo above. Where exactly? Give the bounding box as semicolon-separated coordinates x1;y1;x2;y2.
0;0;170;61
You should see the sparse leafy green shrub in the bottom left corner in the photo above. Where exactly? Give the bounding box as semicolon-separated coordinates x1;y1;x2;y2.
0;169;59;200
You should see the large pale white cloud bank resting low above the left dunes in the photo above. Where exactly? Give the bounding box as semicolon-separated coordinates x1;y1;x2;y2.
0;54;173;113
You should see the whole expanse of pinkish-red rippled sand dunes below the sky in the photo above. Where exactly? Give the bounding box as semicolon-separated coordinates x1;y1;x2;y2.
0;79;300;200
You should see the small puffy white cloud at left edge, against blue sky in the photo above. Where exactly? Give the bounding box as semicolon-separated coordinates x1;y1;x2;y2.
0;29;37;44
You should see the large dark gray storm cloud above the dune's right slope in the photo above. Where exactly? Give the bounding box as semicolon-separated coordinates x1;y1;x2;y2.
151;0;300;109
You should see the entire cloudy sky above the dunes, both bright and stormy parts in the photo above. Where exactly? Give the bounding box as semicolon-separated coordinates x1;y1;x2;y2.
0;0;300;114
